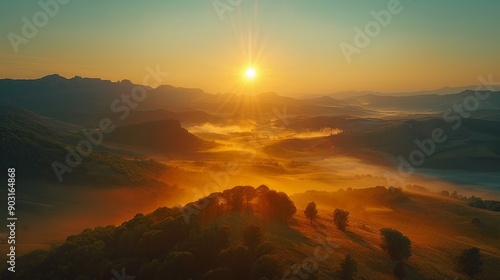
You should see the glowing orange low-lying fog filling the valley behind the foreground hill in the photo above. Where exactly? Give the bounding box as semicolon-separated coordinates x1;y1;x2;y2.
8;124;500;260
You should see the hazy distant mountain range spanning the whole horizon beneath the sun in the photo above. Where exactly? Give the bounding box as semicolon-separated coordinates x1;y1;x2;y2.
0;75;500;122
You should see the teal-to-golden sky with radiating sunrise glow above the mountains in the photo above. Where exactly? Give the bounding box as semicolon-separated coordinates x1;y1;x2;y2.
0;0;500;95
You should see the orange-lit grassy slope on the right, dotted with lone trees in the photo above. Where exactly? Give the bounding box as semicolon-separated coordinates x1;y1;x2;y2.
212;191;500;280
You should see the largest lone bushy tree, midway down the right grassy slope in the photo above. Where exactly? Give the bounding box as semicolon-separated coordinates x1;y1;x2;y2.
380;228;411;260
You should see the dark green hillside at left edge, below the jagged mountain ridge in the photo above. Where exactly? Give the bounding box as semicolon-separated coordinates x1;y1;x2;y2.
0;106;171;187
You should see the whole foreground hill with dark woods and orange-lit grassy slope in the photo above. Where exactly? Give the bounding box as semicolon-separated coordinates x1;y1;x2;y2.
4;186;500;280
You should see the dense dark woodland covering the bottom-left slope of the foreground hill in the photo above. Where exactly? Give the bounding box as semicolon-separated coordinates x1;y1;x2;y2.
0;197;283;280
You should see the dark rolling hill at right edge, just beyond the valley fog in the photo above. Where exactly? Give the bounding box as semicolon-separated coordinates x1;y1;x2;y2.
266;117;500;172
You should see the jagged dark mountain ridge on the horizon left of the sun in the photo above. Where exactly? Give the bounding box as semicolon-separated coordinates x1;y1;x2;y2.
0;75;212;125
